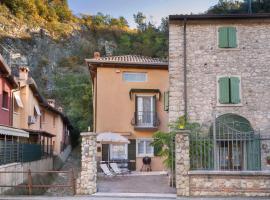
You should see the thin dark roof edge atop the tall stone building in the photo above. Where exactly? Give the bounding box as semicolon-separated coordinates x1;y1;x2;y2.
169;13;270;21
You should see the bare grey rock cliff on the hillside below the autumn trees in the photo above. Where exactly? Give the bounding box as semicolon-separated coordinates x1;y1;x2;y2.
0;25;116;89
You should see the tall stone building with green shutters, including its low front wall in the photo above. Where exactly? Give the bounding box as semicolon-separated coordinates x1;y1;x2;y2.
169;14;270;196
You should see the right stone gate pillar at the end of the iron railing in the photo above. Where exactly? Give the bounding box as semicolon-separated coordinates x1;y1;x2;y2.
175;130;190;196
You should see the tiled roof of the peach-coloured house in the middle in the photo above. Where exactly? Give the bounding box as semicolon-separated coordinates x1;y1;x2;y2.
85;55;168;67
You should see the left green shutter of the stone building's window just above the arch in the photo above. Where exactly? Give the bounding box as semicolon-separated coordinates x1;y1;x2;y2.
218;77;230;104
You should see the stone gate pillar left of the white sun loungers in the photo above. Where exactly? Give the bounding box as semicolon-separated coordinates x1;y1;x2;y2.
76;132;97;195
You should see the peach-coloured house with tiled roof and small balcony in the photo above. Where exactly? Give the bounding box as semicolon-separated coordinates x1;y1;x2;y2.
86;53;169;171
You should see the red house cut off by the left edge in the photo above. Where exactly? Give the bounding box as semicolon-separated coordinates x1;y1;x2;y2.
0;55;18;126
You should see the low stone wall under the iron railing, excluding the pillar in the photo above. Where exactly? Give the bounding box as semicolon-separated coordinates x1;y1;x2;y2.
189;171;270;196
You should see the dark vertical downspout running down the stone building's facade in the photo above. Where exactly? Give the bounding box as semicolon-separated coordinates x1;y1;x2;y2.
183;18;187;122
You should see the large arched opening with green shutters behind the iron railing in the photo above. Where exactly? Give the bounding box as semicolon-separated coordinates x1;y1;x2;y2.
210;114;261;170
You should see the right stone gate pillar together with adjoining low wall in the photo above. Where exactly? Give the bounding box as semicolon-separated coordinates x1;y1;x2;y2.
175;131;270;196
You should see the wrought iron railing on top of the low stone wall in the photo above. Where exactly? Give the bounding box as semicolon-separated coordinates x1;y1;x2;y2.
190;122;262;171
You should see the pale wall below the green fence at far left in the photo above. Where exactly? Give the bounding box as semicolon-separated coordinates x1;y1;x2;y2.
0;158;53;194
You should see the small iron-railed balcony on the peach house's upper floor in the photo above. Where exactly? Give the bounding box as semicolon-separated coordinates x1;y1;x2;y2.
131;111;160;131
